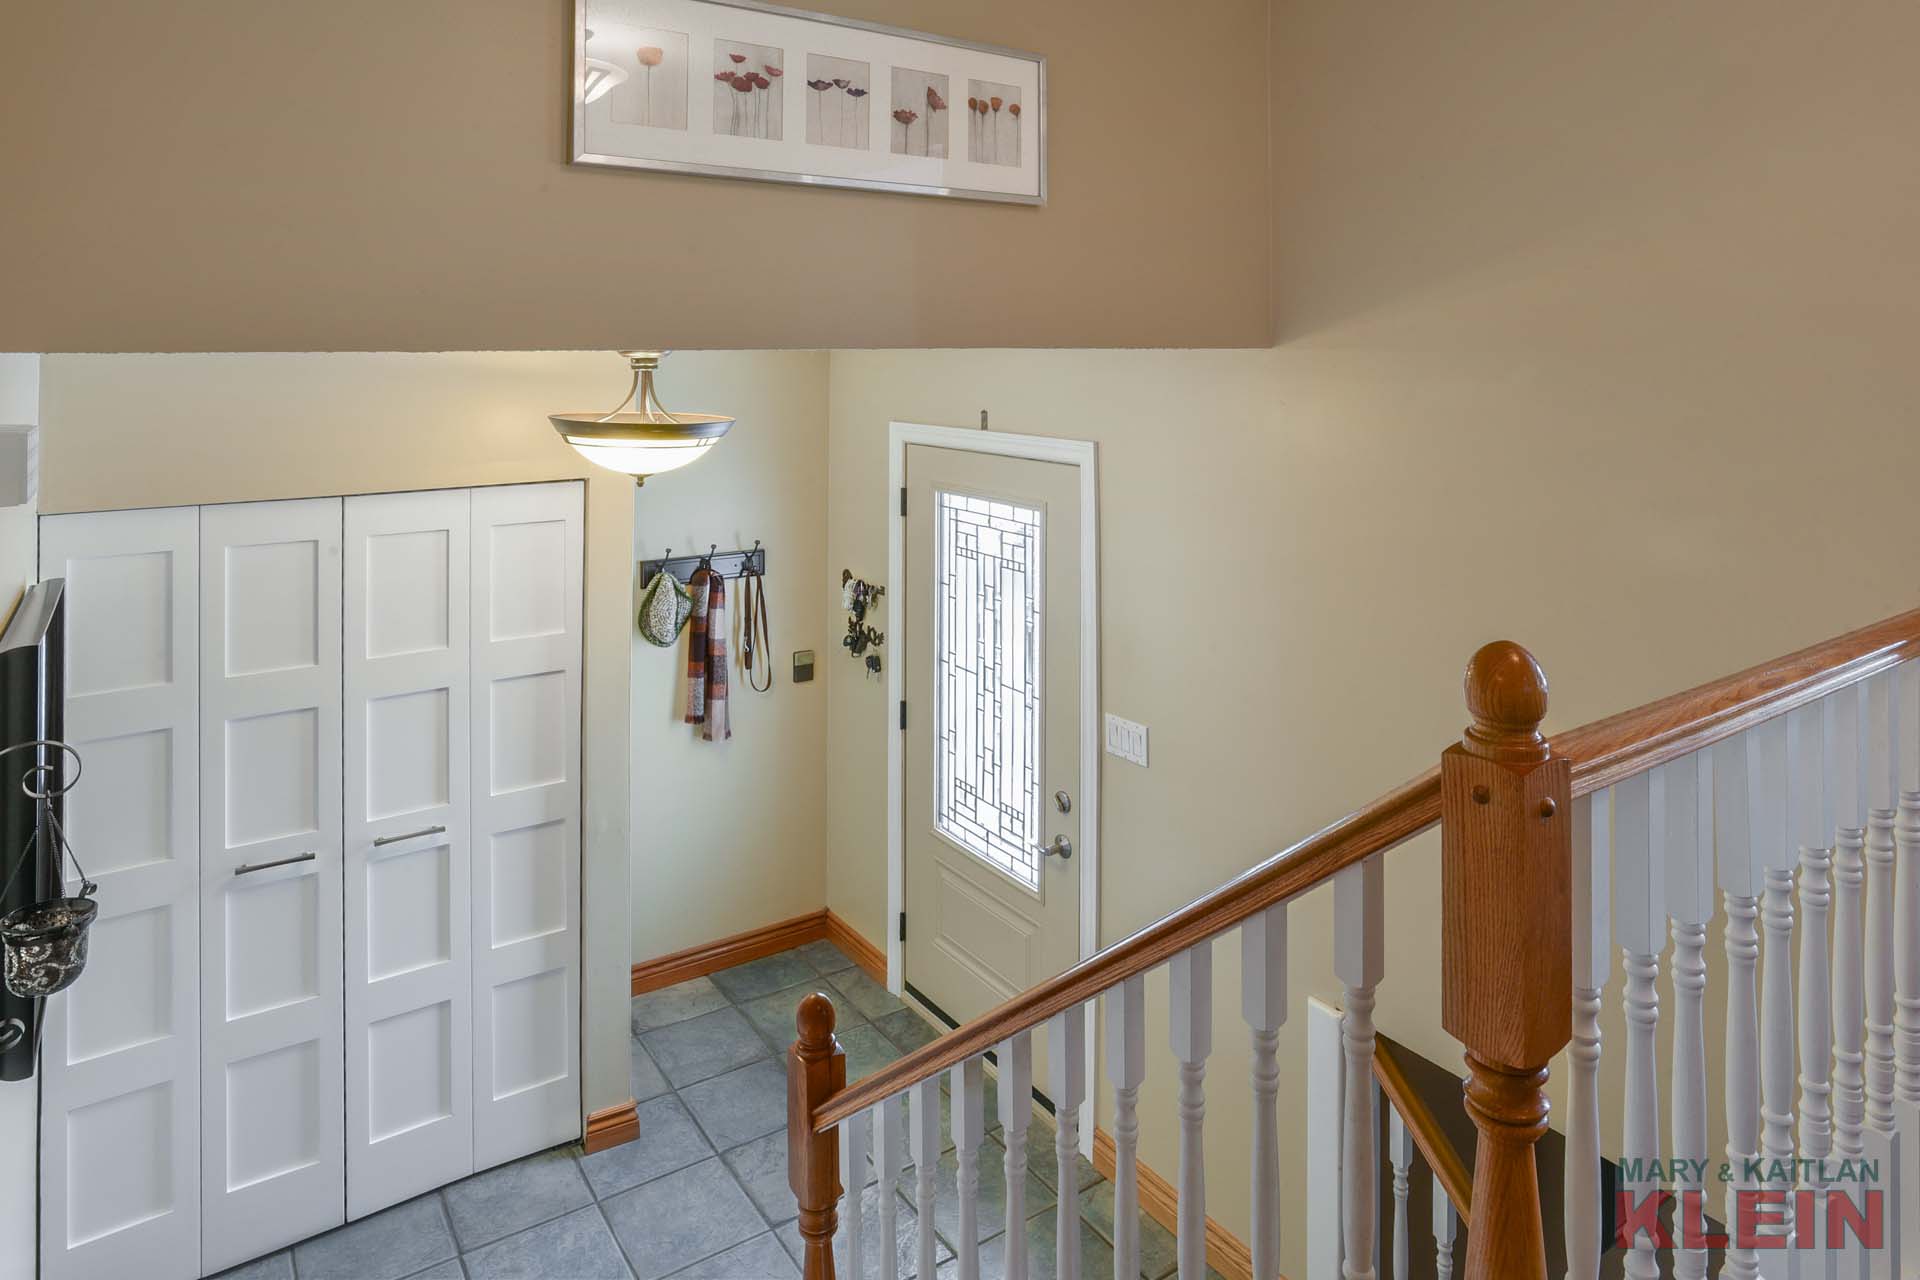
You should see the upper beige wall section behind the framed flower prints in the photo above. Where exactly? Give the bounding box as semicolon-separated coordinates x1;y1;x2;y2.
0;0;1269;351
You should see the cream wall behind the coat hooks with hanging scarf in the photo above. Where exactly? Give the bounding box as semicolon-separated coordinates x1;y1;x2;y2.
632;351;833;960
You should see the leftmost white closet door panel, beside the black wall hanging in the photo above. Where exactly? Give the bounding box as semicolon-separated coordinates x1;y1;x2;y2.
36;507;200;1280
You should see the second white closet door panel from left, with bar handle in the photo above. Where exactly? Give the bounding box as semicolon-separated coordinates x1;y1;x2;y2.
200;499;346;1272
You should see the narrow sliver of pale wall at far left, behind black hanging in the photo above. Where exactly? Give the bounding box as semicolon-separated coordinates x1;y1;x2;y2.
0;353;40;1280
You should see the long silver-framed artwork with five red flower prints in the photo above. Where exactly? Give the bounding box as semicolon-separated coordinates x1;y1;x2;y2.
572;0;1046;205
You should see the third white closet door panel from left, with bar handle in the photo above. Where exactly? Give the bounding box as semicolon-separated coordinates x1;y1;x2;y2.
346;489;474;1217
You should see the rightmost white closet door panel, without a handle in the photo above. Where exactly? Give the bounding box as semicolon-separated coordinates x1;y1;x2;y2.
470;482;584;1169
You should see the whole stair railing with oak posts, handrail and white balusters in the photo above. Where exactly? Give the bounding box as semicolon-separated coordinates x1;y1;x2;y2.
787;610;1920;1280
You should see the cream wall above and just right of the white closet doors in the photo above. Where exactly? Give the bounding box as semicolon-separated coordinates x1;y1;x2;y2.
42;353;820;1109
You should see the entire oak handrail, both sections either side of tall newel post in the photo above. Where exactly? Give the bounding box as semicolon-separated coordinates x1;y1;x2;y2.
812;608;1920;1136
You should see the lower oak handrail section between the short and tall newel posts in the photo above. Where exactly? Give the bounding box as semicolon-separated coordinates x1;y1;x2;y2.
814;770;1440;1132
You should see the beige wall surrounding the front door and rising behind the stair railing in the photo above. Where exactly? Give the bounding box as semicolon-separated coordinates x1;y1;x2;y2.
828;0;1920;1243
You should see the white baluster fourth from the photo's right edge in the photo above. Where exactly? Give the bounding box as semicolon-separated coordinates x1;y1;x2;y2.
1788;702;1834;1221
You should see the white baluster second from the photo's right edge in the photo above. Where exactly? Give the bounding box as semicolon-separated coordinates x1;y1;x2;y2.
1860;672;1901;1280
